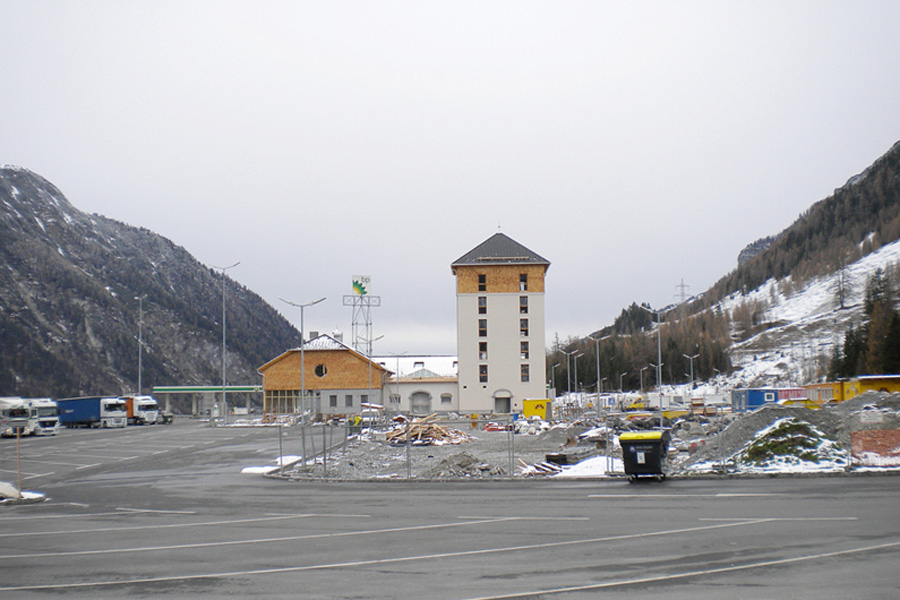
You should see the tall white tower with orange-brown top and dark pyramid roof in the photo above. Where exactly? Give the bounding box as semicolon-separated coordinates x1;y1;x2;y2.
450;233;550;413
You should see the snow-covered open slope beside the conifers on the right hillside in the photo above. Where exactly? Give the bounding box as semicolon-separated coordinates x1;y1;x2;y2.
715;240;900;387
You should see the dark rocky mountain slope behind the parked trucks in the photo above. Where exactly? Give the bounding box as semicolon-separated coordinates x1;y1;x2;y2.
0;166;298;406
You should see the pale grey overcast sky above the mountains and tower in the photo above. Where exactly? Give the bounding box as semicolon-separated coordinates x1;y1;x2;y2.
0;0;900;354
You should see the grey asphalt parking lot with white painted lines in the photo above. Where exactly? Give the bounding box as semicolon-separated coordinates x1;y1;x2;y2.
0;419;900;600
